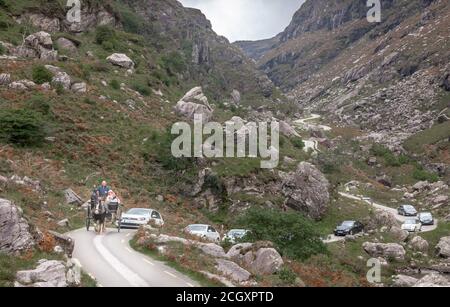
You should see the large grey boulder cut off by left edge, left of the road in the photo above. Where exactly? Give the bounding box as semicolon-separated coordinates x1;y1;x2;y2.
0;198;35;254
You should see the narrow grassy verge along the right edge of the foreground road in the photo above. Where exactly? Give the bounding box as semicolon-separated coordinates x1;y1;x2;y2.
130;239;223;287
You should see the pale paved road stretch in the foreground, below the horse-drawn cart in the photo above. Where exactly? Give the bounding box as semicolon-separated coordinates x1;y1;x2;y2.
68;229;199;287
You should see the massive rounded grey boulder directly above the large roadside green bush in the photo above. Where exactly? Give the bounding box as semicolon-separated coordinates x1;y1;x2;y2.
282;162;330;220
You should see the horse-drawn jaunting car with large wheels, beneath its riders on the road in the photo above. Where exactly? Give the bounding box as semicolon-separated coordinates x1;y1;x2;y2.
86;199;122;234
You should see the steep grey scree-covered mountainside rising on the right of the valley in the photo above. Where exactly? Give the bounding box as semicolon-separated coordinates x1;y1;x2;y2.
238;0;450;154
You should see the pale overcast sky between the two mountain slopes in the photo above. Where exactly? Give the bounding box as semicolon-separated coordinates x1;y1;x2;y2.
178;0;305;42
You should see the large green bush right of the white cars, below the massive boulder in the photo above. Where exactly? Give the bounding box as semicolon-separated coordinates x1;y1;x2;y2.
236;207;327;260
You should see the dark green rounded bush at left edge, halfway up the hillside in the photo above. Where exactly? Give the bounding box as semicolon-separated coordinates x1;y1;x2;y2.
0;109;45;146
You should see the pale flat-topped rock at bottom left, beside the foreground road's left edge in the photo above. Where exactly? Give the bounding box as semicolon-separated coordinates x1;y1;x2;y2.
16;259;68;287
